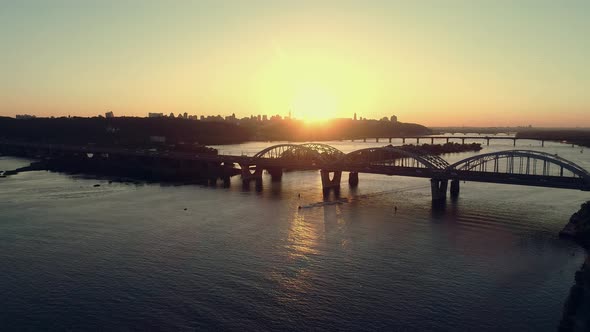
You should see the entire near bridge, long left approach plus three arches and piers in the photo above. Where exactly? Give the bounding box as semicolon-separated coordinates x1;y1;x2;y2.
0;141;590;201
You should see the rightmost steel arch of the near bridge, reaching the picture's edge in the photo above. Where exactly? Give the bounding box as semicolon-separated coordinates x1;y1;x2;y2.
447;150;590;179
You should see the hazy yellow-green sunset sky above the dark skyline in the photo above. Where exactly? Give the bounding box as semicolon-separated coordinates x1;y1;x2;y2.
0;0;590;127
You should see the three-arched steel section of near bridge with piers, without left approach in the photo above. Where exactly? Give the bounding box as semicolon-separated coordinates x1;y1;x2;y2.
253;143;590;193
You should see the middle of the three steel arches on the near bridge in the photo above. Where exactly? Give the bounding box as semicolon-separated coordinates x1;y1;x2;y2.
336;146;449;170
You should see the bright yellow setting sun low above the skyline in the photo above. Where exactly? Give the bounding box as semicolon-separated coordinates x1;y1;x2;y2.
292;87;338;122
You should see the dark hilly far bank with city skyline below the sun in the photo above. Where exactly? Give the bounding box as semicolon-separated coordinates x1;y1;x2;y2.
0;117;430;146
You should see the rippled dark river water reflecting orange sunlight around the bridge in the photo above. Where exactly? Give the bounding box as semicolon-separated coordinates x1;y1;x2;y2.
0;137;590;331
